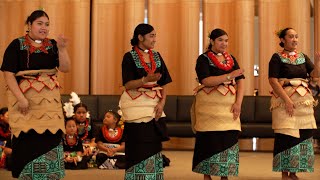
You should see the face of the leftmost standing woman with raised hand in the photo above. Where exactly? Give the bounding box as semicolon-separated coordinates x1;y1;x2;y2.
28;16;49;40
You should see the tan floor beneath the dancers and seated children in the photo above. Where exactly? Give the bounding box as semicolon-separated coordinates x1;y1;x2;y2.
0;151;320;180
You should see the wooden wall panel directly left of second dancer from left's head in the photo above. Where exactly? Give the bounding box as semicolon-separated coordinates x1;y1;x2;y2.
91;0;144;94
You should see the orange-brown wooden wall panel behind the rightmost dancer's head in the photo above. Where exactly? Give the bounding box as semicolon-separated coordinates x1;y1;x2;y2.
259;0;310;95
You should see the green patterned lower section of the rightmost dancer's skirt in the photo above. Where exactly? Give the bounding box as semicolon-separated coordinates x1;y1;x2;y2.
272;138;314;172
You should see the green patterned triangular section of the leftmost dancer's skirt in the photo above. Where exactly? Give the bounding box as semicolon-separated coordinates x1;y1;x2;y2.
19;144;65;180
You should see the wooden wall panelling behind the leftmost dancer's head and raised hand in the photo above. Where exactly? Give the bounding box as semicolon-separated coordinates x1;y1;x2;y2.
0;0;90;106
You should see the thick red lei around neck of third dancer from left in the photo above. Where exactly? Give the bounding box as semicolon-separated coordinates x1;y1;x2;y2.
207;51;234;71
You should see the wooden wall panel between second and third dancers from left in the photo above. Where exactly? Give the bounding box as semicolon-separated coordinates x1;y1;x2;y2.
149;0;200;95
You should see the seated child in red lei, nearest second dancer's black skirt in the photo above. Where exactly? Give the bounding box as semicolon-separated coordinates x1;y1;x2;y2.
96;111;125;169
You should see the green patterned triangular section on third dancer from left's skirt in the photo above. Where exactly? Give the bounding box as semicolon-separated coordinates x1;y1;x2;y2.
192;143;239;176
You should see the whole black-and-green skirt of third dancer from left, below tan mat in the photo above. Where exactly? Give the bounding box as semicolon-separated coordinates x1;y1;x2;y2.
192;130;239;176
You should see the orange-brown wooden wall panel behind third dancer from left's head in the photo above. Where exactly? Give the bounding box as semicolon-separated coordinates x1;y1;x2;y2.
203;0;254;95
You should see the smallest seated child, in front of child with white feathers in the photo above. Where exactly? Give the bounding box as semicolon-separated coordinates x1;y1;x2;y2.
63;118;90;169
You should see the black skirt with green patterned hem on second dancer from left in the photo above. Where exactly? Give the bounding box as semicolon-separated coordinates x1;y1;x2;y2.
124;118;163;180
